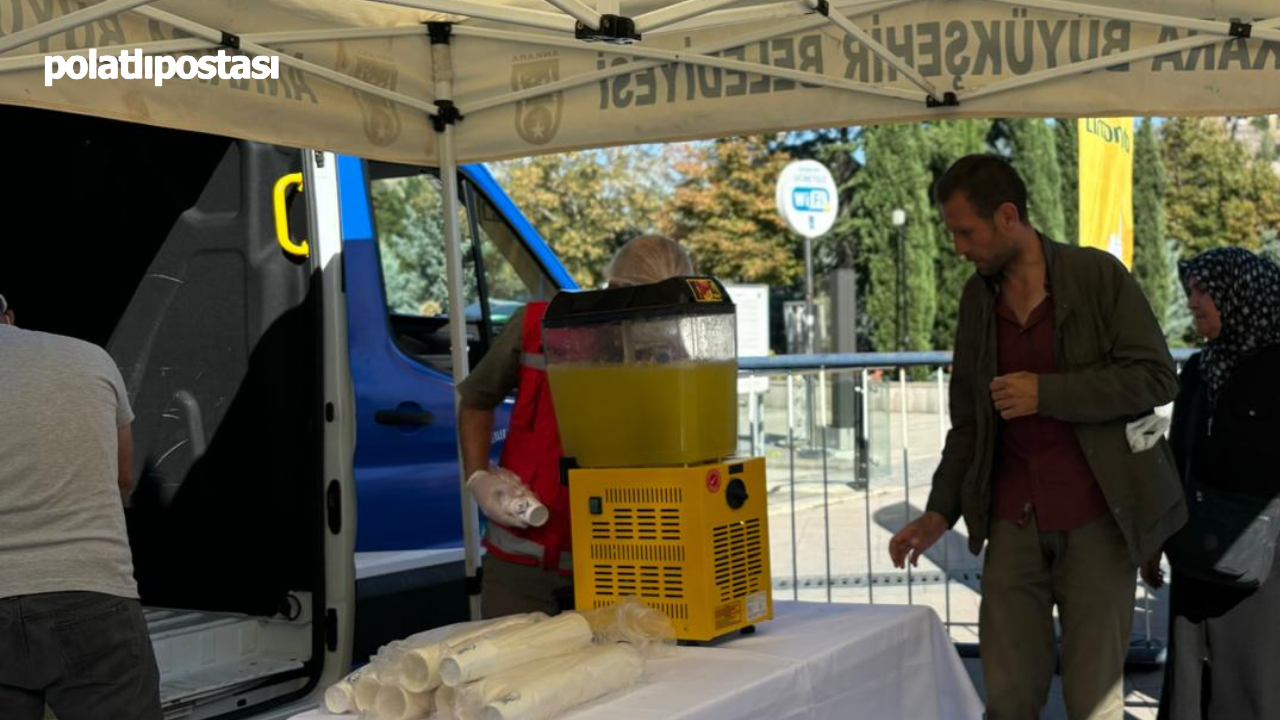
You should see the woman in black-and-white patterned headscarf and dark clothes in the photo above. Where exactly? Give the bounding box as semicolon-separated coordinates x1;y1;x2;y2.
1142;247;1280;720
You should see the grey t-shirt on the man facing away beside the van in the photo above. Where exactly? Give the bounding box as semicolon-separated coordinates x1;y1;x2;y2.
0;325;138;598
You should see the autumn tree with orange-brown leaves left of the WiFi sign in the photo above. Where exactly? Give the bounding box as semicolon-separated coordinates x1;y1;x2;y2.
659;137;804;286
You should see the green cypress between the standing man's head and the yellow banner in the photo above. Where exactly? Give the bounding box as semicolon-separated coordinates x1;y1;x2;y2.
992;118;1066;240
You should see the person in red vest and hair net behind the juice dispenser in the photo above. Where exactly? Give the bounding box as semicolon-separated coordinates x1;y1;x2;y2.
458;234;694;618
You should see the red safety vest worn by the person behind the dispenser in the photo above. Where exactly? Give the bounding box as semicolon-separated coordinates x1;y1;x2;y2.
484;302;573;575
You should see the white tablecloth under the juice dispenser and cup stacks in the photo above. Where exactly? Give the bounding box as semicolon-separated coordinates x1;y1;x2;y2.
294;602;982;720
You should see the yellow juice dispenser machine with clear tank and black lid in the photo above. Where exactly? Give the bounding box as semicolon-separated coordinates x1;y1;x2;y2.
543;278;773;641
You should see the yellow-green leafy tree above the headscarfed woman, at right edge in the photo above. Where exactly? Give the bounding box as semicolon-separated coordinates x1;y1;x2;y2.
1161;118;1280;258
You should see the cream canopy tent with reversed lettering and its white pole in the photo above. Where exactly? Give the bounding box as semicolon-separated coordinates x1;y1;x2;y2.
0;0;1280;617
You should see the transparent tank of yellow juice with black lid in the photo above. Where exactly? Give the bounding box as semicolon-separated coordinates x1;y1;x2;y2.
543;278;737;468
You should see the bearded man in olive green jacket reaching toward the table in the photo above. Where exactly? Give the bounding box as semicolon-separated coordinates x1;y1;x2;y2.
890;155;1187;720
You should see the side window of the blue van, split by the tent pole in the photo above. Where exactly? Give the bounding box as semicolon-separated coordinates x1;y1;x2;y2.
370;163;557;373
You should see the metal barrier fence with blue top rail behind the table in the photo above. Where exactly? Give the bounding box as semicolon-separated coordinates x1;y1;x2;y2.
739;351;1190;664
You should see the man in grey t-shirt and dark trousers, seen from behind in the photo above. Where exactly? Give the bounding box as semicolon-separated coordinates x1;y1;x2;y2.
0;297;161;720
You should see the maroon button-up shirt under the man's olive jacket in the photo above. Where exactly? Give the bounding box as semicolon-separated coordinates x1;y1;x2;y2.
993;297;1107;532
